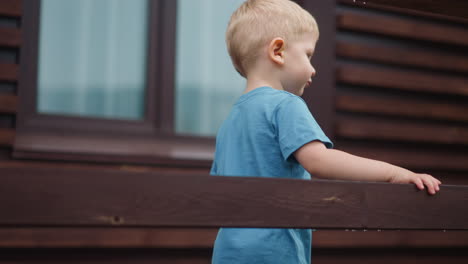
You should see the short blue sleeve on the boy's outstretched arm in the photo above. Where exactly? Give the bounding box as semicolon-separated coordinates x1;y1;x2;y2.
272;96;333;160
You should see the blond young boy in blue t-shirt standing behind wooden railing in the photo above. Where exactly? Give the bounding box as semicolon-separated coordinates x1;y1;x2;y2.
211;0;441;264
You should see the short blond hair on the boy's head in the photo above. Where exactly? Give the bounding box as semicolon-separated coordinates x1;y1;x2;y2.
226;0;318;77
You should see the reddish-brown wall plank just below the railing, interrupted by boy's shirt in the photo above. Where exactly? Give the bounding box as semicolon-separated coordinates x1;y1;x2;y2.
0;227;468;249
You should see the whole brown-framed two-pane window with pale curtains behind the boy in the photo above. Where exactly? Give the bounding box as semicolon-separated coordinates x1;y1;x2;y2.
13;0;333;168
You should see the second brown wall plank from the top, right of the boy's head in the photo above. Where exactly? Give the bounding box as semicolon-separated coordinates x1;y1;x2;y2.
336;40;468;72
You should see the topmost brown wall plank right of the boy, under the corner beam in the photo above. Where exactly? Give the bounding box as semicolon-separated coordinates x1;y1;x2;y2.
337;11;468;46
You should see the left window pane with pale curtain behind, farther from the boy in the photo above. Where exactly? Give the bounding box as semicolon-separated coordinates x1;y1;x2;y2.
38;0;148;120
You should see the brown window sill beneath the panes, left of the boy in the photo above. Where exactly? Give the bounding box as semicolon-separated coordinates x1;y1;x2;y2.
13;132;215;168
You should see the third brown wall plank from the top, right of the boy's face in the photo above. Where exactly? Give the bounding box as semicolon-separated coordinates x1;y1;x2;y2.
336;64;468;96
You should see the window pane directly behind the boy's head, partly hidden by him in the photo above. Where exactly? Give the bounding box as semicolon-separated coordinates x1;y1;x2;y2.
175;0;245;136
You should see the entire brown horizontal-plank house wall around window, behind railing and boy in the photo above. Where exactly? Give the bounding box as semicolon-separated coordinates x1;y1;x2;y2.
0;0;468;264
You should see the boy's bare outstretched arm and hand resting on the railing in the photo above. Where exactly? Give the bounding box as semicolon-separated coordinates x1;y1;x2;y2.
294;141;441;194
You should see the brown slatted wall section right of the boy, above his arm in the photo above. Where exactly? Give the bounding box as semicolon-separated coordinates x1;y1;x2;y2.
335;1;468;184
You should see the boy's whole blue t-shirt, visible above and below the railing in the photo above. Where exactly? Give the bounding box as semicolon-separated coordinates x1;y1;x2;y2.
211;87;333;264
